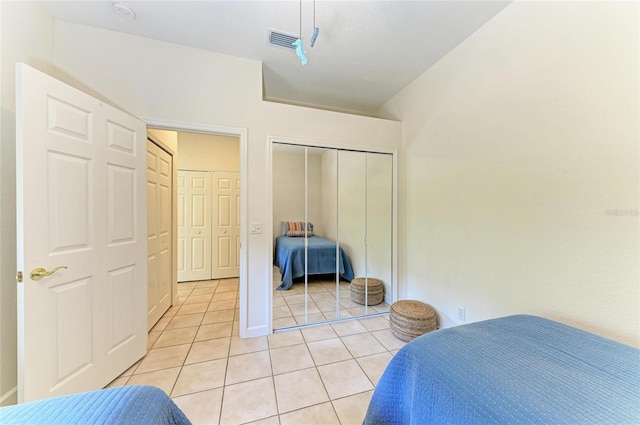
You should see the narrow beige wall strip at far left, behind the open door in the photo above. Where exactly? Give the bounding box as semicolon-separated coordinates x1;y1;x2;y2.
0;1;55;405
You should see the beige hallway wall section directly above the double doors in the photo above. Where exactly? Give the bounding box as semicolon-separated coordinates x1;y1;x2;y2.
178;131;240;172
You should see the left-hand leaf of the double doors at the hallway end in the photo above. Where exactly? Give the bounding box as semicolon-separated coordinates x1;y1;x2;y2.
178;170;211;282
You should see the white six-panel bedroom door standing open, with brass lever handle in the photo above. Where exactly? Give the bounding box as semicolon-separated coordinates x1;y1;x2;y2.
16;64;147;402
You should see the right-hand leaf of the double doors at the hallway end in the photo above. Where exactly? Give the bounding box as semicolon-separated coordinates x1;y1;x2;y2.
211;172;240;279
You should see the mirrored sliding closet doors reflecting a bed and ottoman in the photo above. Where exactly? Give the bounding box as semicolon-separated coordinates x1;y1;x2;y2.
272;142;394;329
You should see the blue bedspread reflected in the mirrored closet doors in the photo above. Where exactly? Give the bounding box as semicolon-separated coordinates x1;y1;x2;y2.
273;236;353;290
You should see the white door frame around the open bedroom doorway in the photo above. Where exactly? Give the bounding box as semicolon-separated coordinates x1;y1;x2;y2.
140;117;249;338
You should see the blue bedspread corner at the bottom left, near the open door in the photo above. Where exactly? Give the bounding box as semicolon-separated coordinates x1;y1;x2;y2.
0;385;191;425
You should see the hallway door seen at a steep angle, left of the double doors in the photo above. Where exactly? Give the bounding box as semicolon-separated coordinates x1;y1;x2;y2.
147;140;173;330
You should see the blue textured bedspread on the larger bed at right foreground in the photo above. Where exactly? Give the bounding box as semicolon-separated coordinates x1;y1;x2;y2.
365;315;640;425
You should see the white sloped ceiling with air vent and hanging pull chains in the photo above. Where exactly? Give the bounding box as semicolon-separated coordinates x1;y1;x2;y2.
41;0;509;115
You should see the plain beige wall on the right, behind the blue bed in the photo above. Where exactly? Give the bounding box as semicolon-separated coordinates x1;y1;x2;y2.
384;2;640;345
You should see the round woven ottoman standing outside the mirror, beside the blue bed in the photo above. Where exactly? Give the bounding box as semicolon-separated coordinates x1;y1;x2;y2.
389;300;438;342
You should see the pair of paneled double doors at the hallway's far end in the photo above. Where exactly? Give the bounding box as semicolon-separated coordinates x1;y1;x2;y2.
178;170;240;282
